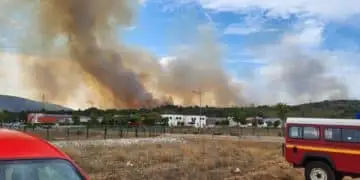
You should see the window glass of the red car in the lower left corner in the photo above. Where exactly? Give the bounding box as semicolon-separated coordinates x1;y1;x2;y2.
0;159;85;180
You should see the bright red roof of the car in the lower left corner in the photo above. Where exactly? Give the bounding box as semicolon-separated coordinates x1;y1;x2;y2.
0;128;69;159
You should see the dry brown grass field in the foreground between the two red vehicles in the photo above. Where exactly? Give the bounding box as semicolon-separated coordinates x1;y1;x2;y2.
63;139;303;180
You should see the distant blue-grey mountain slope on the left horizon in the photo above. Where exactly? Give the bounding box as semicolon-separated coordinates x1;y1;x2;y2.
0;95;71;112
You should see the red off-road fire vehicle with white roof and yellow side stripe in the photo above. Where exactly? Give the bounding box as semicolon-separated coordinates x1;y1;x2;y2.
283;118;360;180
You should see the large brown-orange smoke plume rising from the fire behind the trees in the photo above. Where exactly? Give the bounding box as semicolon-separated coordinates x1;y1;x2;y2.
0;0;246;108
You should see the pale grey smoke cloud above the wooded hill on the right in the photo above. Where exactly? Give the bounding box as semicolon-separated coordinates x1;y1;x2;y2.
255;42;349;103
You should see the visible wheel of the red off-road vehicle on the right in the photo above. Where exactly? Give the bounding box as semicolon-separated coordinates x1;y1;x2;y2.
305;161;336;180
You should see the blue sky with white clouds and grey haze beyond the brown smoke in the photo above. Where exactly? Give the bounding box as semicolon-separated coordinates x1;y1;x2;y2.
0;0;360;107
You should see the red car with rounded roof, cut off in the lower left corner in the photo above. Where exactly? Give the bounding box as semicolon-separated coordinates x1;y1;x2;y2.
0;129;90;180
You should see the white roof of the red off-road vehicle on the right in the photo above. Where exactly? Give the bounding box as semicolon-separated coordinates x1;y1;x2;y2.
286;117;360;126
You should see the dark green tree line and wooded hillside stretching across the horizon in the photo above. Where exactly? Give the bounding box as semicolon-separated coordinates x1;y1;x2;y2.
0;100;360;125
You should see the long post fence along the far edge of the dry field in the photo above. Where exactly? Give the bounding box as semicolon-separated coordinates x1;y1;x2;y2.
4;126;282;141
